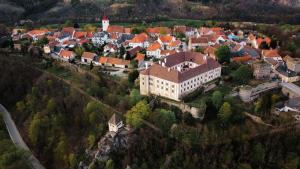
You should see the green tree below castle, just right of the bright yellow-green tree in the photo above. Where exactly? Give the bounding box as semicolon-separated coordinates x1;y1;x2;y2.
154;109;176;132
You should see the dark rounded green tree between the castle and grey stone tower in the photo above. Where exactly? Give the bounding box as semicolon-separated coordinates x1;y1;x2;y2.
232;65;252;84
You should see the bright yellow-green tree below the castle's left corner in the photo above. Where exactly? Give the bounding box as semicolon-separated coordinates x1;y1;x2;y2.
126;100;150;128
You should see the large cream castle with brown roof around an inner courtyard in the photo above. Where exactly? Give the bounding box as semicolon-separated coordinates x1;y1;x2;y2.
140;52;221;101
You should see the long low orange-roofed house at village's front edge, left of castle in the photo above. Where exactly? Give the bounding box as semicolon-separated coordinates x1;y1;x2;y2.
98;56;130;68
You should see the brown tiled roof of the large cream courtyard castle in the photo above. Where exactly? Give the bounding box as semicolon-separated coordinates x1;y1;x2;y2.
141;52;221;83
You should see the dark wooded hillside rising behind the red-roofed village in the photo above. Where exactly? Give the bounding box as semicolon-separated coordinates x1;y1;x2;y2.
0;0;300;23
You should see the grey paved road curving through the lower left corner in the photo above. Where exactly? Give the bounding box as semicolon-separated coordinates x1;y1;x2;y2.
0;104;45;169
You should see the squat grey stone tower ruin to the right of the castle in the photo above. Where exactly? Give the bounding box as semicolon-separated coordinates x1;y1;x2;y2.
252;61;272;80
